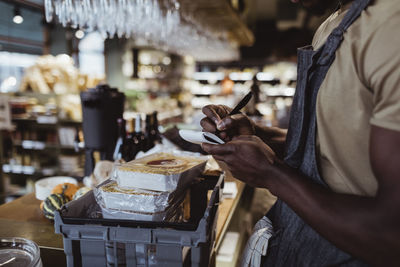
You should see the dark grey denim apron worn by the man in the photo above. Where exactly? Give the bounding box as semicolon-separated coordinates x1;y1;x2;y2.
263;0;370;267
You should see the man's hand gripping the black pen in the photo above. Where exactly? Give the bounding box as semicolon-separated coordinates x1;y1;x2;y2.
200;105;256;142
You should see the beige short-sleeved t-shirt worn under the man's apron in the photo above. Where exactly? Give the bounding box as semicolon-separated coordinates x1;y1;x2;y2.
313;0;400;196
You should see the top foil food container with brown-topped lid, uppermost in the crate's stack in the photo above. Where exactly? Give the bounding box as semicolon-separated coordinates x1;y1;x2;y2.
113;153;207;192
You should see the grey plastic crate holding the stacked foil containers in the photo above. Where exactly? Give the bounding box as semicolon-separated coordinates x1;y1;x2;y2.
54;175;223;267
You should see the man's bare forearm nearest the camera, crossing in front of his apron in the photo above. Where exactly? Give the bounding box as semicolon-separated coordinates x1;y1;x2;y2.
266;164;400;266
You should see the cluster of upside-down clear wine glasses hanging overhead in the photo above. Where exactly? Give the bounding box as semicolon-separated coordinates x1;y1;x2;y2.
44;0;239;61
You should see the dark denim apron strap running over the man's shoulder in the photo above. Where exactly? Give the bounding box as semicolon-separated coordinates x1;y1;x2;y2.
317;0;371;66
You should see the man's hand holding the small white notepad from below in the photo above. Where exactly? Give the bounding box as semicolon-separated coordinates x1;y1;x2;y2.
203;136;278;187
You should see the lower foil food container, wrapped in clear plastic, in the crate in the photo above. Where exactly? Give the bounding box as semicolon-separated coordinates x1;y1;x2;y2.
95;180;185;213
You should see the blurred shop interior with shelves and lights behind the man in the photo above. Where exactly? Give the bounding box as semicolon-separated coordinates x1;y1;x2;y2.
0;0;334;266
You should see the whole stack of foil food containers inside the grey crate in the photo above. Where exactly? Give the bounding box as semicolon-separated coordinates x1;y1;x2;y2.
95;153;206;222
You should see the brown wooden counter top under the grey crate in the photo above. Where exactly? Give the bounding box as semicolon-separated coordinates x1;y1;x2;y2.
0;179;244;267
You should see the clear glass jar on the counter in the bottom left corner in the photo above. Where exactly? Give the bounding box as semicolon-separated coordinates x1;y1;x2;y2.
0;237;42;267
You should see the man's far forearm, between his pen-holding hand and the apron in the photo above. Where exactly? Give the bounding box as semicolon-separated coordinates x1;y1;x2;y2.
255;125;287;159
